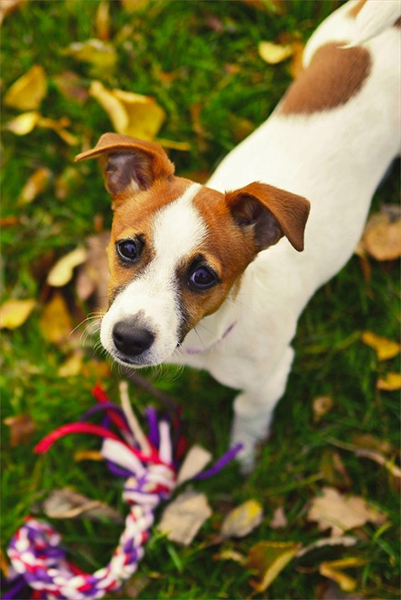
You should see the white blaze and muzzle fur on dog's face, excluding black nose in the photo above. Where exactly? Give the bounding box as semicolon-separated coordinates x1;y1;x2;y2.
100;183;203;366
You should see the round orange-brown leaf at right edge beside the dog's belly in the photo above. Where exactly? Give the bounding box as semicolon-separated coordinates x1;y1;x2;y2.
362;209;401;261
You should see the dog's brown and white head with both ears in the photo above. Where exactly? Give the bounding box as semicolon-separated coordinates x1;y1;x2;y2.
76;133;309;367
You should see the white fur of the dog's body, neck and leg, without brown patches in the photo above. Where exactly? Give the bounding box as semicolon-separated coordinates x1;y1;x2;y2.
166;0;400;467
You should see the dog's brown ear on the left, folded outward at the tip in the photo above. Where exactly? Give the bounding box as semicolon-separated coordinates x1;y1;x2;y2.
75;133;174;207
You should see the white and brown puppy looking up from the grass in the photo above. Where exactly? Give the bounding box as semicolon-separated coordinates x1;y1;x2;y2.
77;0;401;468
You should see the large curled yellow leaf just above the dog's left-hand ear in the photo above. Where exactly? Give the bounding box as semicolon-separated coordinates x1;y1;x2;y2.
89;81;166;141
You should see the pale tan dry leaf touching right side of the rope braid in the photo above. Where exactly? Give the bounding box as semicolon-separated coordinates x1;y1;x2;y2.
157;489;212;546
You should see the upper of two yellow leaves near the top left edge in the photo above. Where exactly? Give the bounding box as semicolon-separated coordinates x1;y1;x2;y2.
4;65;47;110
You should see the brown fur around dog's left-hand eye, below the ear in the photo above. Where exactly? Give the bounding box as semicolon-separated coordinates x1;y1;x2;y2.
107;177;192;304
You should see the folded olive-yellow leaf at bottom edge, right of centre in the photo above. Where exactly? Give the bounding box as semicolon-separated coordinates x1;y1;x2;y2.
246;542;300;592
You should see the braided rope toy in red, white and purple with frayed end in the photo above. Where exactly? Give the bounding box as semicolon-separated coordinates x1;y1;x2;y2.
3;382;241;600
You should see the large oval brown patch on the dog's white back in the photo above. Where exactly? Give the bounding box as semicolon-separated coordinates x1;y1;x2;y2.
278;43;371;115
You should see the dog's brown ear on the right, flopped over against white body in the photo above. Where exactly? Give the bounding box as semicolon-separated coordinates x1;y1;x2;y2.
226;183;310;252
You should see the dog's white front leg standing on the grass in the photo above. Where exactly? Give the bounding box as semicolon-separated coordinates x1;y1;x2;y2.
231;346;294;474
